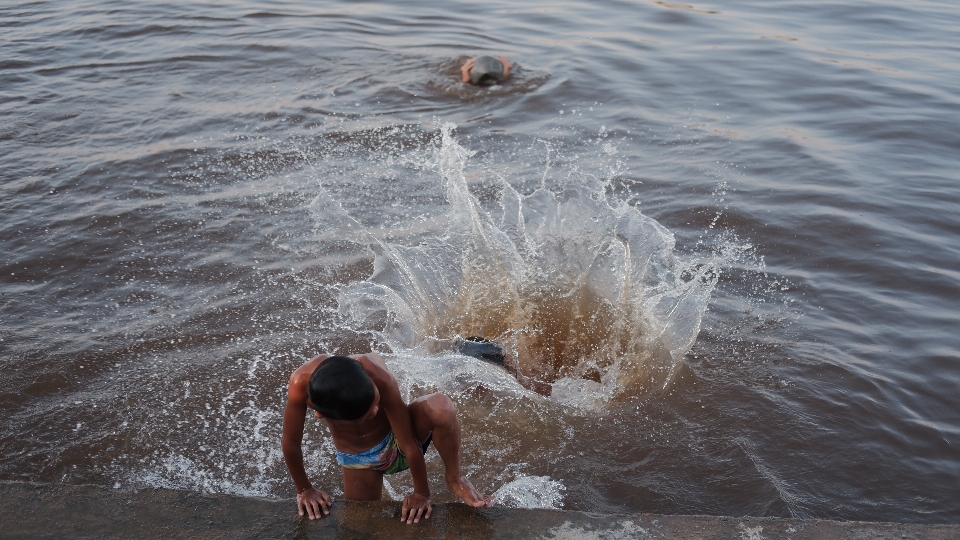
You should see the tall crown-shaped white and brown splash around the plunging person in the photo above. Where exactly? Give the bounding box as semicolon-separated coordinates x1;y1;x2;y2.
313;124;717;407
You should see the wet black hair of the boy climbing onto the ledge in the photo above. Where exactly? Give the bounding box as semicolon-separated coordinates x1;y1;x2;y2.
307;356;376;420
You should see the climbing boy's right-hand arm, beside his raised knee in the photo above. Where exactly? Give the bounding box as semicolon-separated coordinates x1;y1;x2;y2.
364;354;433;523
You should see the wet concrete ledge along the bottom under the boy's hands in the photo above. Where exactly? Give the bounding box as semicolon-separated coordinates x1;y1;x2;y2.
0;482;960;540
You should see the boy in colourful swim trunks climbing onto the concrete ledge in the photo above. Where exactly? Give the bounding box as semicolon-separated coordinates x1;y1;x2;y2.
282;353;493;523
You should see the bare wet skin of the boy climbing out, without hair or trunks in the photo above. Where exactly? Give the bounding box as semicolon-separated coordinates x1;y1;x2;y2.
282;353;493;523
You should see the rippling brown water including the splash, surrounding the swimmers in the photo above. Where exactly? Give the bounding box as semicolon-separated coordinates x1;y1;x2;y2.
0;1;960;522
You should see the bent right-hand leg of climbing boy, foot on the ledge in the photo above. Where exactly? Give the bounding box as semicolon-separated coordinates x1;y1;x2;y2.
407;392;492;507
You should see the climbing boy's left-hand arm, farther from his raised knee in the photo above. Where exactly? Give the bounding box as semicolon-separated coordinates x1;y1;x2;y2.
281;370;330;519
